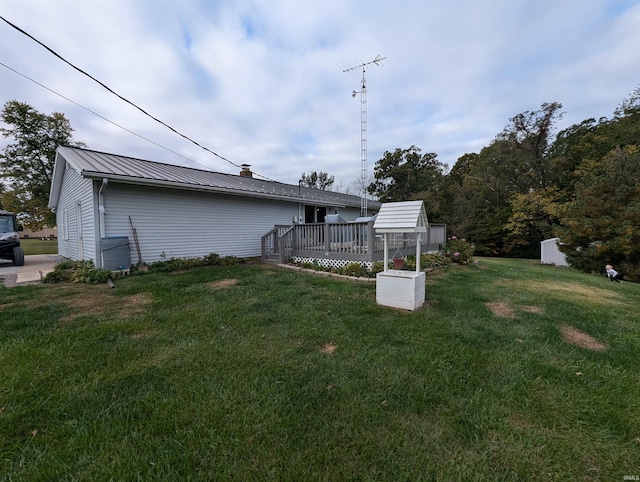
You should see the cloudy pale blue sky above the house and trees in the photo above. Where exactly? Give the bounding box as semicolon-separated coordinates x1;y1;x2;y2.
0;0;640;187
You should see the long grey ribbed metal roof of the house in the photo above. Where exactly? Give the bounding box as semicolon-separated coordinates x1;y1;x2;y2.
49;147;380;209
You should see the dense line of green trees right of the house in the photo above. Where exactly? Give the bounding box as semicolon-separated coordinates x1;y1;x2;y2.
368;87;640;280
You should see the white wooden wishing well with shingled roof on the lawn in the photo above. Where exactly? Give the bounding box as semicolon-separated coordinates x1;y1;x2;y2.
373;201;429;311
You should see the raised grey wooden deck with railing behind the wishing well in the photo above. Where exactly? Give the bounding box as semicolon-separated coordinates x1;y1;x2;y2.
262;221;447;263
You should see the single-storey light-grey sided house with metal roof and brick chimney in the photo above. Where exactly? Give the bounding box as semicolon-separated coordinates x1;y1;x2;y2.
49;147;380;269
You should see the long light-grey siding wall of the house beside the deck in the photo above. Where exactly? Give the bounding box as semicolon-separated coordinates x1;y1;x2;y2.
103;182;299;264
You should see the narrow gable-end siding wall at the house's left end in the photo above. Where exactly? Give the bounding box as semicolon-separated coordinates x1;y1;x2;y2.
56;163;97;261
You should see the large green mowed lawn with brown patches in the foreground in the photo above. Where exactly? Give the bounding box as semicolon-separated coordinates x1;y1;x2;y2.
0;259;640;481
